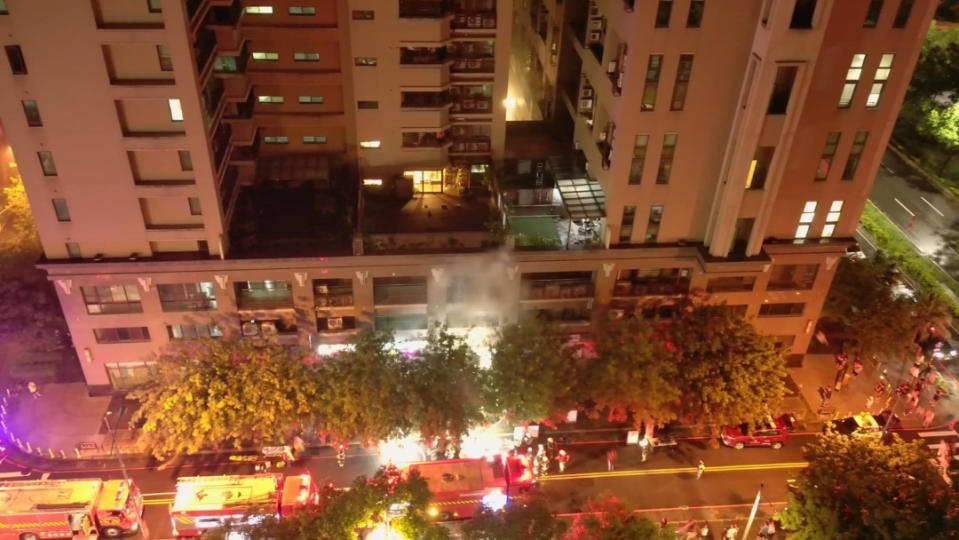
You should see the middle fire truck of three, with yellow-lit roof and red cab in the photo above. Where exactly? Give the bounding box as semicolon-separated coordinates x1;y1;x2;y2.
170;474;320;537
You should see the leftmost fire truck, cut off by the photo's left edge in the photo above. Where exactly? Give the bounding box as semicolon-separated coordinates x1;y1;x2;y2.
0;479;143;540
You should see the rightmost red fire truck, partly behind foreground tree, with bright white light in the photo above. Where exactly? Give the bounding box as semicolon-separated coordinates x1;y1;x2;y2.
403;454;534;521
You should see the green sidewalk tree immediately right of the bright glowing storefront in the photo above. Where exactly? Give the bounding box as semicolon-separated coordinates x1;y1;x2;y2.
484;317;582;423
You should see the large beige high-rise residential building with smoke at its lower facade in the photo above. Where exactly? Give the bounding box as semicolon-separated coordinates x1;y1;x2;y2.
0;0;936;391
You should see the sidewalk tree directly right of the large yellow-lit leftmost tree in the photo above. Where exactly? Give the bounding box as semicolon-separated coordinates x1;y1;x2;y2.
317;330;414;444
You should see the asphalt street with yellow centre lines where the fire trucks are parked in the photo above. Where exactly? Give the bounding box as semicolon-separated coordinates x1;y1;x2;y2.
0;428;959;540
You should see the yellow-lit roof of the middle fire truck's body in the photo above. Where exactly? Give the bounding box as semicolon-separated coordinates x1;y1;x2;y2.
172;474;283;512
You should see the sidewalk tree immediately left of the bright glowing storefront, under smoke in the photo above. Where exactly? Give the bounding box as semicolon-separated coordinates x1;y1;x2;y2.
407;327;483;450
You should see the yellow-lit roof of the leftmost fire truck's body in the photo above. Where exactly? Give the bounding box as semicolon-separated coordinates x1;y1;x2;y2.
0;479;103;514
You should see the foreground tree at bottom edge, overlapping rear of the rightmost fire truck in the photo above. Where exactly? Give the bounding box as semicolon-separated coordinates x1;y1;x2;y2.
210;469;449;540
